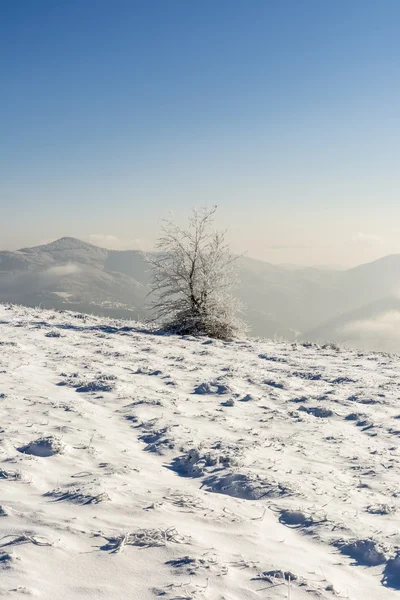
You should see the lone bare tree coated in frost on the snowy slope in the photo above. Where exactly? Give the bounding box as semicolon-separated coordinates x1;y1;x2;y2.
148;206;246;339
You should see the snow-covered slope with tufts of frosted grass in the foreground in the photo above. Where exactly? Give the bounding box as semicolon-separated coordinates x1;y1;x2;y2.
0;306;400;600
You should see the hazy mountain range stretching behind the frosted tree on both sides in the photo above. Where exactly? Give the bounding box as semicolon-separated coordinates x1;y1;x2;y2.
0;237;400;350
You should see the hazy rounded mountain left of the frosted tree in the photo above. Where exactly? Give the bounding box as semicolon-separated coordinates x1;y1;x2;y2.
0;237;148;319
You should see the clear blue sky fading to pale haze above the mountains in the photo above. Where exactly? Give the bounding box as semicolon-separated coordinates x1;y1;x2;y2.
0;0;400;265
